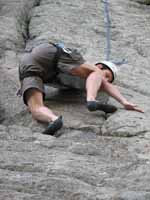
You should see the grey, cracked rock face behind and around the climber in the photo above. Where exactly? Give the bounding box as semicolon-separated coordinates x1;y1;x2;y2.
0;0;150;200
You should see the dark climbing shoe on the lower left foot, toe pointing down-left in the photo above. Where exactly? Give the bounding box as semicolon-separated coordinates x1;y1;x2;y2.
43;116;63;136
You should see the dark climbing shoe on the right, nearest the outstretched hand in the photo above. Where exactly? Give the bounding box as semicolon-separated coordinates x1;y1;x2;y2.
87;101;117;113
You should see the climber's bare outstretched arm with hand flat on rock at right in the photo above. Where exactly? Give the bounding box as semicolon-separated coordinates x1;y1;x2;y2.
101;79;144;112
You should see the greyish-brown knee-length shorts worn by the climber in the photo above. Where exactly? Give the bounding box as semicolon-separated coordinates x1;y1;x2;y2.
19;43;85;104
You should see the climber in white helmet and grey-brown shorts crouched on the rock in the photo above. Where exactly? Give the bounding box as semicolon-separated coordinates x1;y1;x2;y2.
19;43;143;135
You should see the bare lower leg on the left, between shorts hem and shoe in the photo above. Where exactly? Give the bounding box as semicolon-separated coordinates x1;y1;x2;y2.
26;89;58;122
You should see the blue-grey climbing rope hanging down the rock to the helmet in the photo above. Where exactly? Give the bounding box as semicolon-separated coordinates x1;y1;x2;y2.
102;0;127;65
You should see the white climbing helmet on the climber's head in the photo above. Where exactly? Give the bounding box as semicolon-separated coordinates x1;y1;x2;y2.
96;61;118;82
